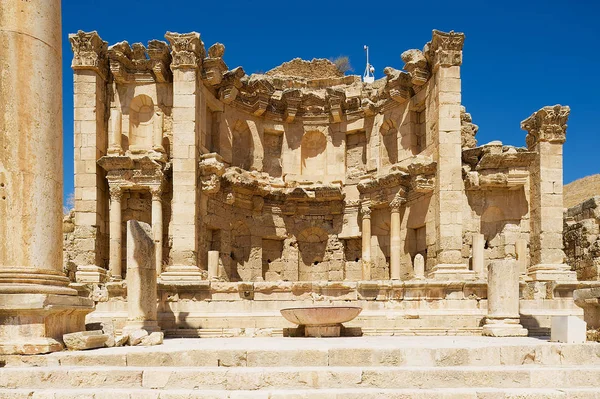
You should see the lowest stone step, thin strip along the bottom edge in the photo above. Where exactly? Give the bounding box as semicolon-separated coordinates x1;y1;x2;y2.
0;388;600;399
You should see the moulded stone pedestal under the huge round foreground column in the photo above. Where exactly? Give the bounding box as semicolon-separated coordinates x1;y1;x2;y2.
0;292;94;355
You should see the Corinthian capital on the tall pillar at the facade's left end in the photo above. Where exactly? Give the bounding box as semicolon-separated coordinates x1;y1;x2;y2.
69;30;108;77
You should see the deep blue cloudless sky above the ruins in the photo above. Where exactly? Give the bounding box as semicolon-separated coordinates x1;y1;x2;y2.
62;0;600;202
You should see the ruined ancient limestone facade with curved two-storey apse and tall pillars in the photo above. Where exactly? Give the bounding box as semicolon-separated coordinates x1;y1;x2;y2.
52;31;596;336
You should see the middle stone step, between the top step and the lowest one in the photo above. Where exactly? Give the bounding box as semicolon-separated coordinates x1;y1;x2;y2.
0;365;600;391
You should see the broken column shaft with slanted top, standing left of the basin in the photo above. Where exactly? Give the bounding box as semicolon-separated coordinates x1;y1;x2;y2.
123;220;160;334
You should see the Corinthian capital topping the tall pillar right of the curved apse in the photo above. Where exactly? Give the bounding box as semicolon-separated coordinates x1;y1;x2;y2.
424;29;465;70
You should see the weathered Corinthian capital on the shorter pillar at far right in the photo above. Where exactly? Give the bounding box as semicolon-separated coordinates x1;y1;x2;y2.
521;104;571;149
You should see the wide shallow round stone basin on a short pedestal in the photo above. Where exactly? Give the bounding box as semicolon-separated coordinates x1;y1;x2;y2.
281;306;362;337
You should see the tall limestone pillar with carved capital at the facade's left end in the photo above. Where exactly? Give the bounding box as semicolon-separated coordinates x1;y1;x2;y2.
69;31;110;283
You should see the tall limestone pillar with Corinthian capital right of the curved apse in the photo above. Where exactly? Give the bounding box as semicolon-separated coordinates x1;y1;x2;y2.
426;30;475;280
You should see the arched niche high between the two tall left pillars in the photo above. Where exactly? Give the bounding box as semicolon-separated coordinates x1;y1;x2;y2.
129;94;154;151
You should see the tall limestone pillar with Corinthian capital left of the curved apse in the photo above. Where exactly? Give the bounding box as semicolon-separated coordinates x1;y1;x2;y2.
161;32;205;281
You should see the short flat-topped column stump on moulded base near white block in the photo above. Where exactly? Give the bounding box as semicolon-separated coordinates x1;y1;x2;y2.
483;259;527;337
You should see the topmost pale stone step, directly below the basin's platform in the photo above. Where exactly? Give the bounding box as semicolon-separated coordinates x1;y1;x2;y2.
0;337;600;367
